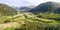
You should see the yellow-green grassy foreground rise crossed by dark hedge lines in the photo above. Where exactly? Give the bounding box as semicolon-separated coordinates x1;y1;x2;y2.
0;12;60;30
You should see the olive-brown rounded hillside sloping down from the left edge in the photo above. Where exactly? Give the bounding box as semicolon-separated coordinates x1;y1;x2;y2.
0;3;17;16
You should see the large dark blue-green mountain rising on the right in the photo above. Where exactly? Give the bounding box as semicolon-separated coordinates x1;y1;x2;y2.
29;2;60;13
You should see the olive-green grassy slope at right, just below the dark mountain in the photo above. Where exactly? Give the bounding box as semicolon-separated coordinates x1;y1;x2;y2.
37;13;60;21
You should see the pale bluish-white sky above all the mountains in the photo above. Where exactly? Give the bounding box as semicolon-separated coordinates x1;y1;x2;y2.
0;0;60;7
